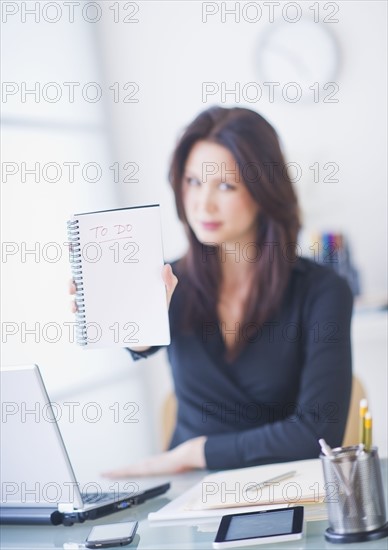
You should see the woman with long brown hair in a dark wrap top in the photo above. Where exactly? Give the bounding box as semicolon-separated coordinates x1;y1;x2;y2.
71;107;353;478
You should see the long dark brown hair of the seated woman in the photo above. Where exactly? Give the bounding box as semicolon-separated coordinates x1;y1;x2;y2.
169;107;300;358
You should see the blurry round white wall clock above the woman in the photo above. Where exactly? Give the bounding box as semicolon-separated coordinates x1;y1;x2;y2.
256;20;339;91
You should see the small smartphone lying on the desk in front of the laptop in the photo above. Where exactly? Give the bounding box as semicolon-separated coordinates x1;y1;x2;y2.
85;521;138;548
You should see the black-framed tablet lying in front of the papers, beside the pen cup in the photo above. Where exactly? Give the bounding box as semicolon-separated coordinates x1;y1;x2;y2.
213;506;304;549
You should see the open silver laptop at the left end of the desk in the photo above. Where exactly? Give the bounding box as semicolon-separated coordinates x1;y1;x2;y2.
0;365;170;525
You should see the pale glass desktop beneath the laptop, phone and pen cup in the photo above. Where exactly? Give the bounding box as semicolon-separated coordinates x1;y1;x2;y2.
0;459;388;550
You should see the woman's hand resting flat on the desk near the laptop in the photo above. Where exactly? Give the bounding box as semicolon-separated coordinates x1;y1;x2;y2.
102;436;206;479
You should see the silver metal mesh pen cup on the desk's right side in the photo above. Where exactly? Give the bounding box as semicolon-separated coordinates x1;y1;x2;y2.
320;446;388;543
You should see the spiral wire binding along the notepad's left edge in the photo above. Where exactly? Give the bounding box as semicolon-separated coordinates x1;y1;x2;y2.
67;220;88;346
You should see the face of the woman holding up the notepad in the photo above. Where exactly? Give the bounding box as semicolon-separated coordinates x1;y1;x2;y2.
182;141;259;245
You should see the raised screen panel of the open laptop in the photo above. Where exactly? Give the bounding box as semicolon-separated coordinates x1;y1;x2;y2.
0;365;83;508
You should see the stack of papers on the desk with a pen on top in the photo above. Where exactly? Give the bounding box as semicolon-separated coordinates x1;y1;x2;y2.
149;459;325;521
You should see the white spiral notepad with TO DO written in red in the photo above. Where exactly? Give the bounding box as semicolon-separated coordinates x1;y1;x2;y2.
67;204;170;348
